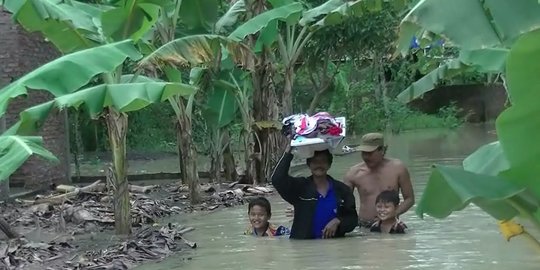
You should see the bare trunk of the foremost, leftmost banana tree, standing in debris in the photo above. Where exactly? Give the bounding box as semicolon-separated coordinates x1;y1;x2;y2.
105;108;131;235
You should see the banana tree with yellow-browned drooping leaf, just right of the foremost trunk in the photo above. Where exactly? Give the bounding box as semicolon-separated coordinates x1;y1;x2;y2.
147;0;254;196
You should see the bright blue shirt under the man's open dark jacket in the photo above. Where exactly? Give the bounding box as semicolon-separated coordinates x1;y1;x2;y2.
312;181;337;238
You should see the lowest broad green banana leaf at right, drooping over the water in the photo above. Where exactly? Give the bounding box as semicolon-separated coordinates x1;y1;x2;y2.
416;165;540;220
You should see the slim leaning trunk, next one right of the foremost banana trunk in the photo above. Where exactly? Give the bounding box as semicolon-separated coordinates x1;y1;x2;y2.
177;98;201;204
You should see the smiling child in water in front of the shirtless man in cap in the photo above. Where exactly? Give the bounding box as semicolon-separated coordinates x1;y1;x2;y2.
370;190;407;233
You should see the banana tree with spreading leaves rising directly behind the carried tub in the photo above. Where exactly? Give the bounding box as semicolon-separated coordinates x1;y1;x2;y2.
229;0;407;115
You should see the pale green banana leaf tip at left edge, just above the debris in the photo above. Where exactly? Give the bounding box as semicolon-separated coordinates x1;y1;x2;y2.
0;135;58;181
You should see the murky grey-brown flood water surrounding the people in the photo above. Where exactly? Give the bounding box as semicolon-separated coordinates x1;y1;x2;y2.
137;125;540;270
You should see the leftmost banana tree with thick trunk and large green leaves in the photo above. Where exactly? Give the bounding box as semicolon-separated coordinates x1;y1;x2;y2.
0;0;200;234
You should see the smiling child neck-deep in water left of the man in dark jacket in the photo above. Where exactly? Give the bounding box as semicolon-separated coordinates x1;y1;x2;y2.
244;197;290;236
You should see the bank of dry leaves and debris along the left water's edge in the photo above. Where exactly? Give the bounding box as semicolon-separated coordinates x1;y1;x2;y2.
0;181;274;270
